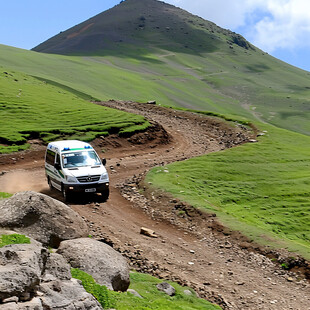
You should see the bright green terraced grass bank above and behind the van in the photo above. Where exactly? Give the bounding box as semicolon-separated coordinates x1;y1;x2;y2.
0;70;149;153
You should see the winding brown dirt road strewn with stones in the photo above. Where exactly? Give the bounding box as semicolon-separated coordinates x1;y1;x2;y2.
0;102;310;310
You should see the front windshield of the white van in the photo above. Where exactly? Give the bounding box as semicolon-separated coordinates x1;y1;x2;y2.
62;151;101;168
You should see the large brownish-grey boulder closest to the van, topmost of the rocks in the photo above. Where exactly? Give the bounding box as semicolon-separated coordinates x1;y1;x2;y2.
0;191;88;247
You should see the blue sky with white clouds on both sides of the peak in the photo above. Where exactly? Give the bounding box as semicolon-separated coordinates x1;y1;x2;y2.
0;0;310;71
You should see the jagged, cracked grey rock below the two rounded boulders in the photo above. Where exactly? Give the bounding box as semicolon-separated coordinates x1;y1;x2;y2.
0;231;102;310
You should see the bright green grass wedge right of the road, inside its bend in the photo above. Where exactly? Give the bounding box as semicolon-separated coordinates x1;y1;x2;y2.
146;124;310;258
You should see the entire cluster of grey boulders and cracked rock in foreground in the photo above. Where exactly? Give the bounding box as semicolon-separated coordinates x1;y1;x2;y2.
0;192;129;310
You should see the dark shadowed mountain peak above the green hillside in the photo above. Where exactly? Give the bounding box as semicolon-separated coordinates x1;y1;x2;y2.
33;0;255;55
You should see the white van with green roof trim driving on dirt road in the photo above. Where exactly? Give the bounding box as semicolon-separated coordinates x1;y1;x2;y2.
45;140;109;200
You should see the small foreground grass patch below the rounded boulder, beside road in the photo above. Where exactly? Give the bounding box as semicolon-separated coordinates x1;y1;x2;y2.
71;269;221;310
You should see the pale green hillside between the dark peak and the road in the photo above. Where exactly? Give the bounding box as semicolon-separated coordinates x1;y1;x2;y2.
0;41;310;135
